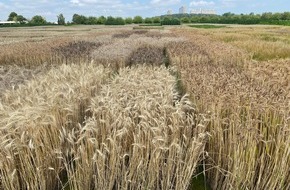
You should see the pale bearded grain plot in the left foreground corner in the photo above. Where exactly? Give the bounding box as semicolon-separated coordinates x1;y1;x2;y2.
0;64;110;189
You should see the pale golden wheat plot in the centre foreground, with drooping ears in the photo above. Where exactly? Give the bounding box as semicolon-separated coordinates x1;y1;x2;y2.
66;66;205;190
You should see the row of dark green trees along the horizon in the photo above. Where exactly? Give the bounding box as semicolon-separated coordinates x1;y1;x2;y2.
3;12;290;26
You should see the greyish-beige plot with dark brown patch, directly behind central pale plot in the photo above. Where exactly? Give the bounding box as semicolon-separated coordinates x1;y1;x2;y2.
92;32;184;70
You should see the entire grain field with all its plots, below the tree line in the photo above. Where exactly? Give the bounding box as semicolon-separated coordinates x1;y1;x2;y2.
0;26;290;190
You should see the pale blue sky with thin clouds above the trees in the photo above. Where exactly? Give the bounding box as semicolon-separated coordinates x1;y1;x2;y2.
0;0;290;22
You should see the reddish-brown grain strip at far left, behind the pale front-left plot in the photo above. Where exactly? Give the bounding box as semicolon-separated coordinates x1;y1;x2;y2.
0;35;111;69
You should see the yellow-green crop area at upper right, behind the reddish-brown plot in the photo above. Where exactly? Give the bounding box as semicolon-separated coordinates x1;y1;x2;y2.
188;26;290;61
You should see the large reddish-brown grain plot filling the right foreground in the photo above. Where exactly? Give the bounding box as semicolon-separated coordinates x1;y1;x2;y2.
168;31;290;189
